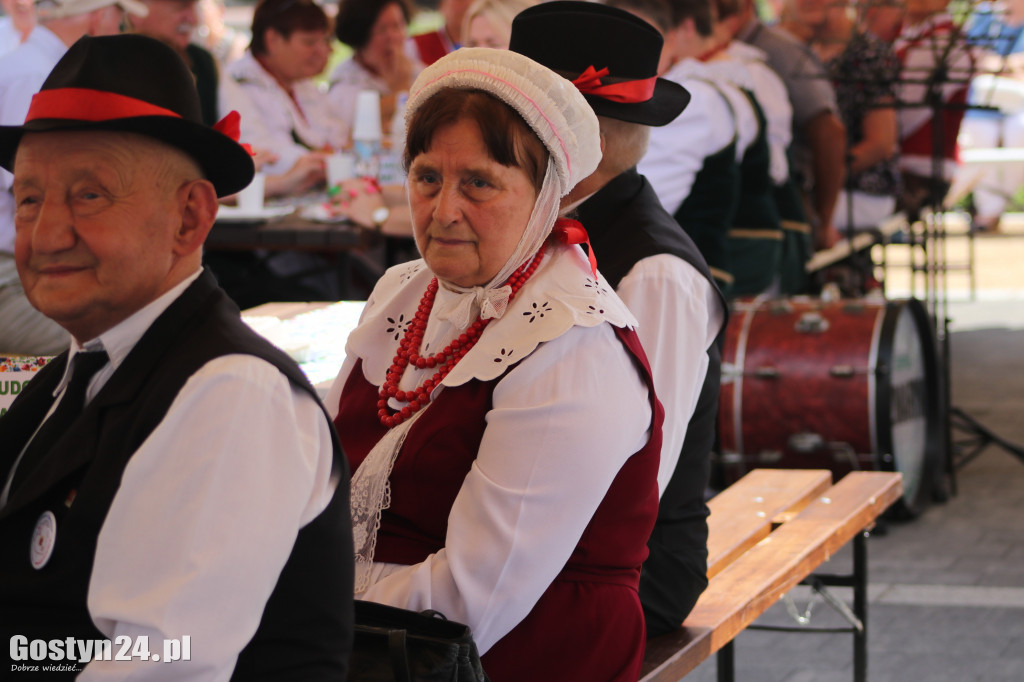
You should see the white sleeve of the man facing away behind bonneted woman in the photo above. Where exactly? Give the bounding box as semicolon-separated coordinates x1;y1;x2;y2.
615;254;725;494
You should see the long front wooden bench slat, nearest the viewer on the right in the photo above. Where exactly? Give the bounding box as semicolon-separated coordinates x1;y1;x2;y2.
642;471;903;682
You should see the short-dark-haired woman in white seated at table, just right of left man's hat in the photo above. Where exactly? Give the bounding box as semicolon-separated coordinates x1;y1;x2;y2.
218;0;348;307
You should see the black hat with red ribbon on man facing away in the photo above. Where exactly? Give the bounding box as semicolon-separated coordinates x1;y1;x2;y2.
509;0;690;126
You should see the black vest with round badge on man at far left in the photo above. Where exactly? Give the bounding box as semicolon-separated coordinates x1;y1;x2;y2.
0;272;353;680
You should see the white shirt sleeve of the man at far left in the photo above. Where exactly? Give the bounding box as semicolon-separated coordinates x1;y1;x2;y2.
79;355;336;682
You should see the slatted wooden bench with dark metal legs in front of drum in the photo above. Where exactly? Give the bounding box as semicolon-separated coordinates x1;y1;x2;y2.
642;469;903;682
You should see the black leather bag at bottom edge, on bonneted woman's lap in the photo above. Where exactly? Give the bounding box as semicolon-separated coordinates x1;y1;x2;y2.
348;599;488;682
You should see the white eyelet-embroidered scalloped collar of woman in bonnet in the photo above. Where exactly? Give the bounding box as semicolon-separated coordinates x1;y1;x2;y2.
346;246;636;386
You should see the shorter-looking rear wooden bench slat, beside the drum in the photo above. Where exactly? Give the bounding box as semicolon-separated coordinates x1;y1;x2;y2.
708;469;831;580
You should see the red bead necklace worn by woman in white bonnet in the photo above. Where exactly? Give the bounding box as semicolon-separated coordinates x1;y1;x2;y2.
377;243;547;429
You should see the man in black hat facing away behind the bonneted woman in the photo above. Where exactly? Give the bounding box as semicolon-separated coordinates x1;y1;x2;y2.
510;2;726;635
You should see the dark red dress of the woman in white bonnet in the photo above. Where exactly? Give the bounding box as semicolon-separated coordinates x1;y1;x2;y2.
335;329;664;682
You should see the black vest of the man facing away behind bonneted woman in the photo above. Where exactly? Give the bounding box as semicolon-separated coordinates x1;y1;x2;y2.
579;166;733;636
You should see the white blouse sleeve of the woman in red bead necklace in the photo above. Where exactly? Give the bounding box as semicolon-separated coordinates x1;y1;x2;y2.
362;325;653;653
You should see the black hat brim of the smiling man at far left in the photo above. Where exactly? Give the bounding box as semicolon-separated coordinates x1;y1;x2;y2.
0;116;255;197
